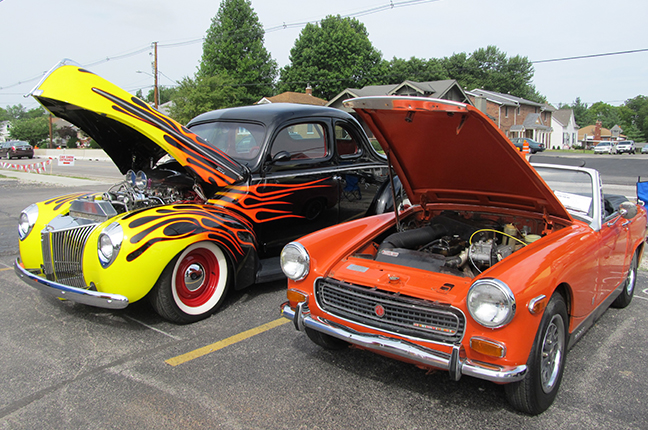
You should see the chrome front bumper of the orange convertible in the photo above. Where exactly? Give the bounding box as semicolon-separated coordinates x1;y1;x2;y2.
281;303;527;383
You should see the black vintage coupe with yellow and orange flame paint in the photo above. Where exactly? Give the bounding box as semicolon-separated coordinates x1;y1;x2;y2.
14;65;388;323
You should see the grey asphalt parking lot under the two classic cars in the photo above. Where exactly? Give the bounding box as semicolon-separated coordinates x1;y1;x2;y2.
0;163;648;429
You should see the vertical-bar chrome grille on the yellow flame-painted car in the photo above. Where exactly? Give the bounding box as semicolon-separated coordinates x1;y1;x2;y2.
41;224;97;288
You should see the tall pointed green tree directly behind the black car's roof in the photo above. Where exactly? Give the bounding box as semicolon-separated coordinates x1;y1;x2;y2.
196;0;277;104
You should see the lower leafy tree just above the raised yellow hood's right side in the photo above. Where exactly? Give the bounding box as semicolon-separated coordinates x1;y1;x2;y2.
170;72;249;124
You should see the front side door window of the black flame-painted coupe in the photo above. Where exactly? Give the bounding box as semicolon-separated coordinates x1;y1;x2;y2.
270;123;328;160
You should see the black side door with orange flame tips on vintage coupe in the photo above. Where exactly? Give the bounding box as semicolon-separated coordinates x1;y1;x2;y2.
255;118;338;256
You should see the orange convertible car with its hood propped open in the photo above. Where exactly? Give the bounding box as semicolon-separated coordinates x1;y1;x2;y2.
281;97;646;414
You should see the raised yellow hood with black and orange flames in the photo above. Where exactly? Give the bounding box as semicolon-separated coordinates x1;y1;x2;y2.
31;65;246;186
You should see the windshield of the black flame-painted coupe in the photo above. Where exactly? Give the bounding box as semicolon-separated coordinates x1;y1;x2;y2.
191;121;265;162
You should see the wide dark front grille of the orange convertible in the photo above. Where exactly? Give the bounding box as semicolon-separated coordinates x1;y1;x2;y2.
315;279;465;343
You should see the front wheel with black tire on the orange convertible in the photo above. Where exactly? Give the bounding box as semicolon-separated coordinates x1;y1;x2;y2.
504;293;568;415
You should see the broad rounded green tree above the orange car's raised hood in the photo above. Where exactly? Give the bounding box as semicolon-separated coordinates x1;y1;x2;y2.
279;15;387;100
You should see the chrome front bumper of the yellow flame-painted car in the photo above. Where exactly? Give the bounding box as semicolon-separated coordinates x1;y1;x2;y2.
14;259;128;309
